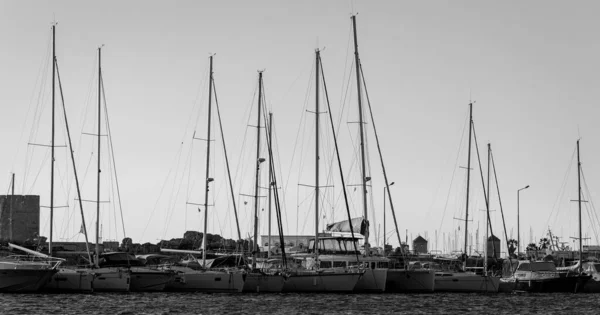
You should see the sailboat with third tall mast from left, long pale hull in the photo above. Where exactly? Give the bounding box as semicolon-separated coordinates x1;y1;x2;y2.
161;56;246;292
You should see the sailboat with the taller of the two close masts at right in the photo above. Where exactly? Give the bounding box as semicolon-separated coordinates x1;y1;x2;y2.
435;103;500;293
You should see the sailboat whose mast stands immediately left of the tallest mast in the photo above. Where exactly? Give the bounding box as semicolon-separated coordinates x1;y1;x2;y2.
283;49;370;292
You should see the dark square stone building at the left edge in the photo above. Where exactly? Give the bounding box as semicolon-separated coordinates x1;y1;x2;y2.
0;195;40;243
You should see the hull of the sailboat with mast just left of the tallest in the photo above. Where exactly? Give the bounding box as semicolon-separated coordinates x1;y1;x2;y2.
283;271;362;292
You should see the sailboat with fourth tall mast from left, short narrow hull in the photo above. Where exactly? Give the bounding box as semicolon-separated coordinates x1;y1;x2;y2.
243;71;285;292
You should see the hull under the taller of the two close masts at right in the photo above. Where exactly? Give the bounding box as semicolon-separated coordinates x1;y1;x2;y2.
435;272;500;293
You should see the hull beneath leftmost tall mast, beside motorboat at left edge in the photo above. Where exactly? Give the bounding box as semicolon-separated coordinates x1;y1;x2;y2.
44;268;94;293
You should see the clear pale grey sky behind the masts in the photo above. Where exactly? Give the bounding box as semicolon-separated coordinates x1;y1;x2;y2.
0;1;600;256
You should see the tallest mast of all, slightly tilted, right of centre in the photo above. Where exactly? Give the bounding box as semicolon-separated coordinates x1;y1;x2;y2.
352;15;370;254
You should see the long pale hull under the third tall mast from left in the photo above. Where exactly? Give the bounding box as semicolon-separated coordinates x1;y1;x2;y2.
165;267;245;292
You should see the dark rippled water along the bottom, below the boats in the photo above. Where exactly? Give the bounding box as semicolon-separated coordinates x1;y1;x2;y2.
0;293;600;314
